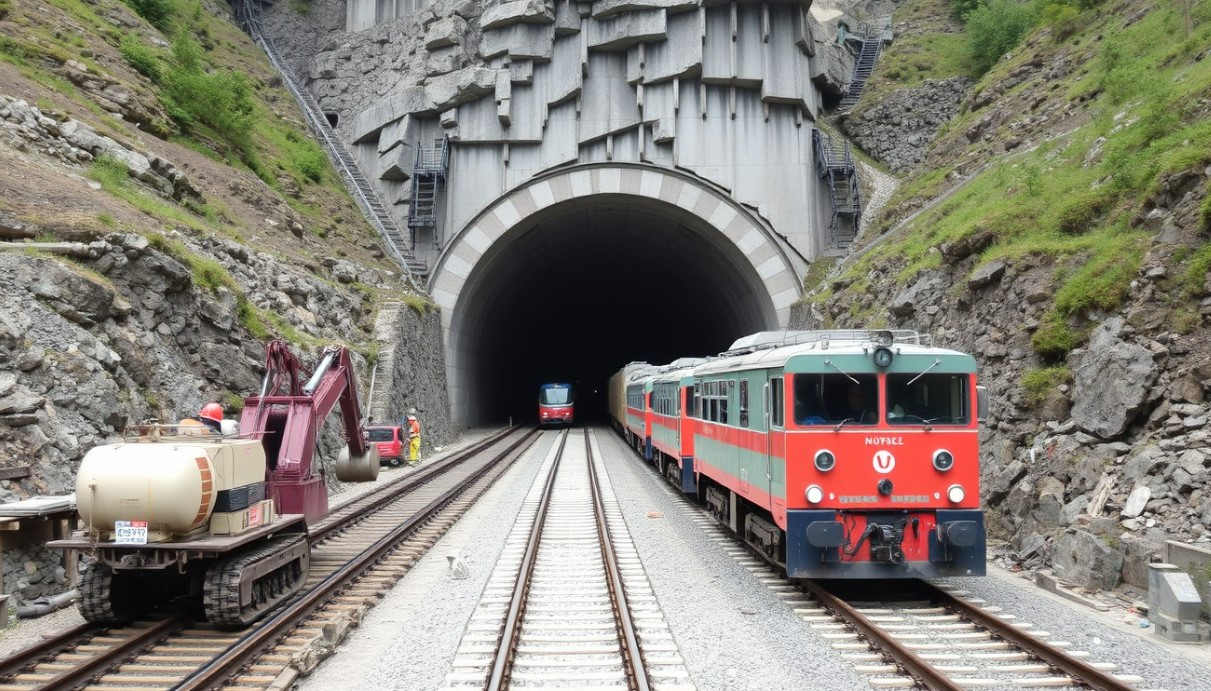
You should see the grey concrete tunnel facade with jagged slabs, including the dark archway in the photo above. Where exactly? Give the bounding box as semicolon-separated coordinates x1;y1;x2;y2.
309;0;862;425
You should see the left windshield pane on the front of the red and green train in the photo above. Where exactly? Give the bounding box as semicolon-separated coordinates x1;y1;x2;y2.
792;373;879;425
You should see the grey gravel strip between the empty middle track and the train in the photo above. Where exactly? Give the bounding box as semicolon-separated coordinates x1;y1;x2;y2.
597;428;871;691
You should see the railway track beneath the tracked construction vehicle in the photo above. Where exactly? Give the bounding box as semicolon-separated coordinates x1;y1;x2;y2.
0;430;536;691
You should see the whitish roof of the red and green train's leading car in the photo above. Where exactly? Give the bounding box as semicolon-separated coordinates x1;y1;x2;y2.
694;330;975;375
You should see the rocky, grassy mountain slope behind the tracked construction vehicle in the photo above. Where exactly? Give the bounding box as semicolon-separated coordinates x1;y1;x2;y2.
0;0;453;601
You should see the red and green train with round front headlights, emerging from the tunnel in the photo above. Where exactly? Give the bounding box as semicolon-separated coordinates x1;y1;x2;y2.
612;330;986;578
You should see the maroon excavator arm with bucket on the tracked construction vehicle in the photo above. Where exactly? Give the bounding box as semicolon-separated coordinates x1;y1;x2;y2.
240;341;379;522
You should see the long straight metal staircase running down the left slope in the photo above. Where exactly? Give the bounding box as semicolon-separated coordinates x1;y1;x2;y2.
231;0;429;281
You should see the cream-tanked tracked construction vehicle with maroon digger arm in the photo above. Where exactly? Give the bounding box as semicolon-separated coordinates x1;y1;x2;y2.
48;341;379;627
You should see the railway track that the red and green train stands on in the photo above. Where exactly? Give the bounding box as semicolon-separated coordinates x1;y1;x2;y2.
618;433;1143;691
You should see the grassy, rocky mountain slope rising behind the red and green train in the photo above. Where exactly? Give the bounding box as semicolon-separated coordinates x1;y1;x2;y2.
796;0;1211;587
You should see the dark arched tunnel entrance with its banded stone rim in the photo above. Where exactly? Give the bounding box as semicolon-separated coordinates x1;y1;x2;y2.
434;168;798;425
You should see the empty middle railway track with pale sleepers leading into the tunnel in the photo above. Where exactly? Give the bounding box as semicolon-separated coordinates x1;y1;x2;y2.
446;430;694;691
